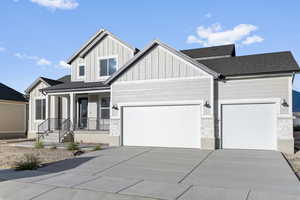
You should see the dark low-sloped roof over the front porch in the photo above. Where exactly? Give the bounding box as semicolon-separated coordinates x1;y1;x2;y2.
42;81;110;92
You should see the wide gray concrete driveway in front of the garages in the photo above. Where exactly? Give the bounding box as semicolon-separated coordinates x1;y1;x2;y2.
0;147;300;200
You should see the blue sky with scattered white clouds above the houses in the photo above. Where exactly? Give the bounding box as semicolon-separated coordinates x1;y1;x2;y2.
0;0;300;92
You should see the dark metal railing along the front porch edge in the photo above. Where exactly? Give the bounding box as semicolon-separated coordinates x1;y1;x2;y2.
74;117;110;131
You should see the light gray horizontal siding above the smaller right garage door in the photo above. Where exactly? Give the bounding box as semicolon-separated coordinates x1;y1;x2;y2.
215;77;292;114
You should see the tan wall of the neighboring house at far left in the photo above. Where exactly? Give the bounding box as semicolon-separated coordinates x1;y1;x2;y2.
0;102;26;134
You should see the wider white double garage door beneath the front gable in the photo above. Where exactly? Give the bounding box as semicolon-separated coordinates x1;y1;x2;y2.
123;105;201;148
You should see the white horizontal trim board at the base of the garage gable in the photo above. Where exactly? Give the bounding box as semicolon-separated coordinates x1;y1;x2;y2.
113;76;213;85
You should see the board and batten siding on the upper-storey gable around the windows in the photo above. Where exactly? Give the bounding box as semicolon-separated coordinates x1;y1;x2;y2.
71;35;134;82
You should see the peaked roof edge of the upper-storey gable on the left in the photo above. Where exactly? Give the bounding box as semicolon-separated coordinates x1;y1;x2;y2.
67;29;137;64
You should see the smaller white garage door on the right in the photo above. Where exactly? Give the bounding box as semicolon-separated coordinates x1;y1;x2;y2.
222;104;277;150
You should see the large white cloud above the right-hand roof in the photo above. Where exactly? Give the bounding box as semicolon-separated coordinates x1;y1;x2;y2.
186;23;262;47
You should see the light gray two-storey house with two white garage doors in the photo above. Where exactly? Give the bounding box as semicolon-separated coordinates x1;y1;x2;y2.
26;30;300;152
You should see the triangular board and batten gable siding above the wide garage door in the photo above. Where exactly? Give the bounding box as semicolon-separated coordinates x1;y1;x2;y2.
117;46;208;81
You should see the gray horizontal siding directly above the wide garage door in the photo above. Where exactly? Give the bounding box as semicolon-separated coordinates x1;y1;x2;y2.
112;78;212;116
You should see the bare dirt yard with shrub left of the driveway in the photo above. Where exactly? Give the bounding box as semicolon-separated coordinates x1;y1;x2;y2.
0;144;74;169
